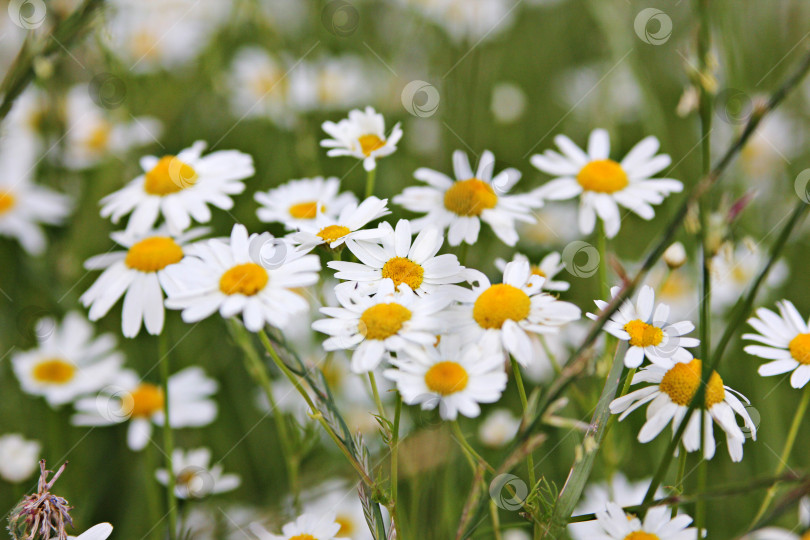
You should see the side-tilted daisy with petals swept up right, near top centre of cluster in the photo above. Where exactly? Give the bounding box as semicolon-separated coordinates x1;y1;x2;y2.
290;197;391;251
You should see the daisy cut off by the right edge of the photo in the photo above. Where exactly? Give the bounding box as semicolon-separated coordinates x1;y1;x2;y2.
743;300;810;388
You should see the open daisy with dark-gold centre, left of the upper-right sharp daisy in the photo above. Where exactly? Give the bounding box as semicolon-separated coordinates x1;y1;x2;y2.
393;150;542;246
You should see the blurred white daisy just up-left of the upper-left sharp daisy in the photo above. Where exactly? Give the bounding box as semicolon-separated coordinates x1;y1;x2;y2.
64;84;163;169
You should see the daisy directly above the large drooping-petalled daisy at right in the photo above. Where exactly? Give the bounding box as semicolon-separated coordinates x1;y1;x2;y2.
587;285;700;368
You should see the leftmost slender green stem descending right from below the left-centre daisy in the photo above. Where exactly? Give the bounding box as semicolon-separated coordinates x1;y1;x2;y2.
228;319;301;510
